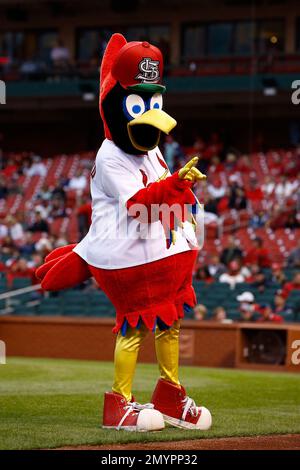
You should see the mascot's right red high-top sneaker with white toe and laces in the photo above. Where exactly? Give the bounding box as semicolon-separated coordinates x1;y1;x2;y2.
151;379;212;431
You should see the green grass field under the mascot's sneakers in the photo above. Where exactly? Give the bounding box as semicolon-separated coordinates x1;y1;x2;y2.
0;358;300;449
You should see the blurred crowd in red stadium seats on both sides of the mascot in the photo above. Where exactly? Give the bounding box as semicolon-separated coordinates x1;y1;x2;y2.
0;133;300;322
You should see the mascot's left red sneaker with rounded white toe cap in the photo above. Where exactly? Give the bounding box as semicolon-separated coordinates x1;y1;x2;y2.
103;392;165;432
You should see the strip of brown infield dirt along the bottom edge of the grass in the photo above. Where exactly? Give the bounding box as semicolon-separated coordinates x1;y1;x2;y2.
59;434;300;451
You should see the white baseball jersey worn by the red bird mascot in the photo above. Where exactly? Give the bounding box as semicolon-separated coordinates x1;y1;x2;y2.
74;139;190;269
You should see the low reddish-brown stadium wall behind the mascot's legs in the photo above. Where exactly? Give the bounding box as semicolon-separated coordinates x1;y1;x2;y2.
0;316;300;372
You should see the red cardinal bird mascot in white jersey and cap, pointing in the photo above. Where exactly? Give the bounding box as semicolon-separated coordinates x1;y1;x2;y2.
37;34;211;431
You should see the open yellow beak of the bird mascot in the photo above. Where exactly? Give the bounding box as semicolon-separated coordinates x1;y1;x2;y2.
127;109;177;151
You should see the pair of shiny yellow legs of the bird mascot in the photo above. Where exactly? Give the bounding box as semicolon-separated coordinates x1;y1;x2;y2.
113;321;180;400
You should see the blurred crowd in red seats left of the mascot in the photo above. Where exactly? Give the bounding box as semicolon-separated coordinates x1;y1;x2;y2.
0;152;92;287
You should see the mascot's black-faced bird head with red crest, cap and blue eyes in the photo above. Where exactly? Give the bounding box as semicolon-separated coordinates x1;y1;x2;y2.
99;34;176;155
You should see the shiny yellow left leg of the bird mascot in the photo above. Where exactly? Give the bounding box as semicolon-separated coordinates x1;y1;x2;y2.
112;325;147;401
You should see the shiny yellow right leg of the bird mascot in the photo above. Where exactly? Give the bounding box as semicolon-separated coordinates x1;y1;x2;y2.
155;321;180;385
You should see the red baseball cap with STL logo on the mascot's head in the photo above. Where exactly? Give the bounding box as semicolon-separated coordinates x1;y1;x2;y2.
111;41;165;92
